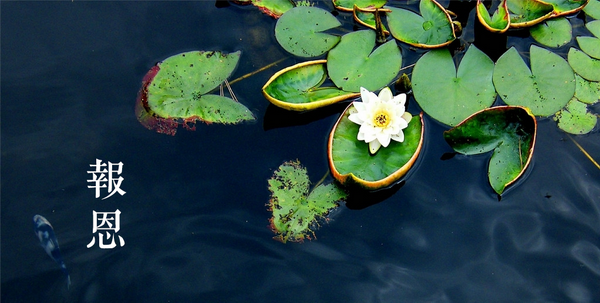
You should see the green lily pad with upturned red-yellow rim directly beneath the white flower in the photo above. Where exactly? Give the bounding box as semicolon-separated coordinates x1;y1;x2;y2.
327;104;424;190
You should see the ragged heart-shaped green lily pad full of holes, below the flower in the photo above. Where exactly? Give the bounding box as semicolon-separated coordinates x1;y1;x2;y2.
268;161;347;243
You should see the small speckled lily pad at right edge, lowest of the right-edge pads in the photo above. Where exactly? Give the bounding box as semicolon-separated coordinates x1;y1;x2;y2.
554;98;598;135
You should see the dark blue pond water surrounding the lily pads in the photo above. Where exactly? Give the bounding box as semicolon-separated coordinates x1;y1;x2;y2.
1;1;600;303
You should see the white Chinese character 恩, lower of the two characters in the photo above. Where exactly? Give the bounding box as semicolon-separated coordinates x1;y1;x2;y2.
87;209;125;249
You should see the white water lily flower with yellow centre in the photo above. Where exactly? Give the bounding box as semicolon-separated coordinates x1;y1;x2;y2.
348;87;412;154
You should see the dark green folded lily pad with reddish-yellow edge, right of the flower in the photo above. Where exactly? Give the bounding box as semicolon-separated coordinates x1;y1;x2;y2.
444;106;537;195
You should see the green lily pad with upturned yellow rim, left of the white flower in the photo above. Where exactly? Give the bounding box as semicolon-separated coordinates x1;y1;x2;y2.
262;60;360;111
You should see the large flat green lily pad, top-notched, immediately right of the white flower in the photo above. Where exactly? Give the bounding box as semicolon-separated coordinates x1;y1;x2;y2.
412;45;496;125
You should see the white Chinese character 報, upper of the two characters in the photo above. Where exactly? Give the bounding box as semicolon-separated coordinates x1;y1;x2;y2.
87;159;125;200
